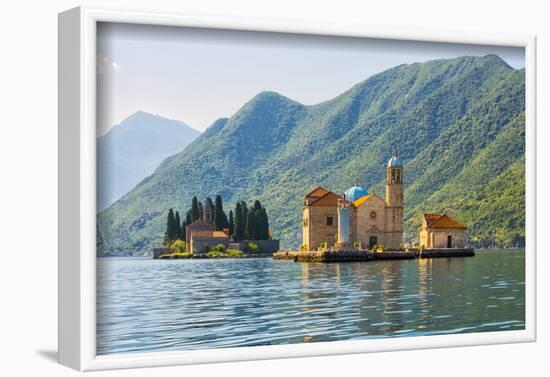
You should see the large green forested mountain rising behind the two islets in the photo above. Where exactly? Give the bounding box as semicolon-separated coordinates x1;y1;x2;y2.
98;55;525;250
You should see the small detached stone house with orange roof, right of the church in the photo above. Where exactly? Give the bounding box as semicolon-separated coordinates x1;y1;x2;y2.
420;213;468;249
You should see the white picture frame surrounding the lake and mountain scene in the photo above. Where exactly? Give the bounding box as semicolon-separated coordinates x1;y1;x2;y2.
58;7;536;371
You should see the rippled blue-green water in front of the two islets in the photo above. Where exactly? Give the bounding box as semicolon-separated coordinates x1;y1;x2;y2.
97;250;525;354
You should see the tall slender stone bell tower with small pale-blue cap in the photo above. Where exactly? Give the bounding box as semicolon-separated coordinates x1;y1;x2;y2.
386;148;403;250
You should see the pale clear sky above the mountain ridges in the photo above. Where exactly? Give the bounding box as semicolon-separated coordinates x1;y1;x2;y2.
97;23;525;136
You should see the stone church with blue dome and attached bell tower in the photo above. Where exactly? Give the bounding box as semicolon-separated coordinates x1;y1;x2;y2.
302;150;403;250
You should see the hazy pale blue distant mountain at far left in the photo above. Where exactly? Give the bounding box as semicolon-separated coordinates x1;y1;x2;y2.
97;111;200;211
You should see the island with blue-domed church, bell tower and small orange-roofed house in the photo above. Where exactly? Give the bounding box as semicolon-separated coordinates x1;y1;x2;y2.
273;147;475;262
